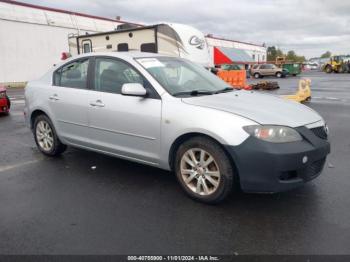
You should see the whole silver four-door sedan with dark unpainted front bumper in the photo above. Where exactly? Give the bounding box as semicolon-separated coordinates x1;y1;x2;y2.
25;52;330;203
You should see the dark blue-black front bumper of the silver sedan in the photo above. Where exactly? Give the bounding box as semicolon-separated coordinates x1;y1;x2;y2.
226;127;330;192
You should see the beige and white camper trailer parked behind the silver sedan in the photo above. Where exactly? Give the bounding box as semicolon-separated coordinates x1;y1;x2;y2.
69;23;214;68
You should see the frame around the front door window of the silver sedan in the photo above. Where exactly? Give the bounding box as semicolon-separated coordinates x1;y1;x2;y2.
88;56;161;99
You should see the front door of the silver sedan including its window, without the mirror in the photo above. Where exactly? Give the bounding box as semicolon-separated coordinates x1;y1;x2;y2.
89;57;162;164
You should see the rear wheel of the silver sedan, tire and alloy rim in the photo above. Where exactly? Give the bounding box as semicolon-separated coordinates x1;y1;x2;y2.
33;115;67;157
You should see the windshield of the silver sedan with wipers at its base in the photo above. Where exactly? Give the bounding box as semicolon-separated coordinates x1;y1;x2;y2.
136;57;233;96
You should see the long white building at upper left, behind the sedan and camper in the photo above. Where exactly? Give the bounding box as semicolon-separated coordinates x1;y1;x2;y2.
0;0;135;83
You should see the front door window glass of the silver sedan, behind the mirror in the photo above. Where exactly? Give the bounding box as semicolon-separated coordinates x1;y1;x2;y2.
95;58;145;94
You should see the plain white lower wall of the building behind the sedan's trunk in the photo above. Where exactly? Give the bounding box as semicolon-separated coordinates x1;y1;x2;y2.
0;20;83;83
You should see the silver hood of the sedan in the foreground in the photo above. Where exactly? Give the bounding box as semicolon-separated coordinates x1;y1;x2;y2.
182;90;322;127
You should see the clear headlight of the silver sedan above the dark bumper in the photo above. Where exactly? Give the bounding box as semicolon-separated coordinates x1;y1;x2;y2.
243;125;303;143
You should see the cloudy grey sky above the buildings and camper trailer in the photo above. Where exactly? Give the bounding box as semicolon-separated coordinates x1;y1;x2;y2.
19;0;350;58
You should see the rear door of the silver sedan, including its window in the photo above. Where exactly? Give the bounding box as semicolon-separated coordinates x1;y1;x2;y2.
48;58;90;144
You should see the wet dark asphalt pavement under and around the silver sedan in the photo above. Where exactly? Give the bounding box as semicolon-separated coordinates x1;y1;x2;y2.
0;72;350;254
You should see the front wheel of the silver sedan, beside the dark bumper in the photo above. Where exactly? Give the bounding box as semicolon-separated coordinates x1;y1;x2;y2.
175;137;234;204
